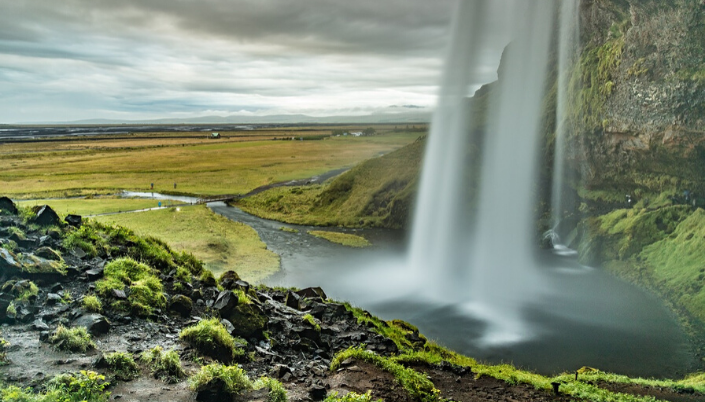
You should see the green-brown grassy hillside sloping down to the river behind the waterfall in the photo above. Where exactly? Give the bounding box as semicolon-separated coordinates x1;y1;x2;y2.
236;139;424;228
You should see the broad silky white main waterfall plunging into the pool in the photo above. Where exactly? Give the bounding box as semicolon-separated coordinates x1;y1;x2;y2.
409;0;577;342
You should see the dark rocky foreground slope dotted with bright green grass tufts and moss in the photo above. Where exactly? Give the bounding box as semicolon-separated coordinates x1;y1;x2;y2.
0;198;703;402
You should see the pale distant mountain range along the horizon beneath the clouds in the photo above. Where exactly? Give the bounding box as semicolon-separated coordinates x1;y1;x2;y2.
52;111;431;125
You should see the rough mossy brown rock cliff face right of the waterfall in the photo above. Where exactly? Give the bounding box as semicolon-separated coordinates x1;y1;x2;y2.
571;0;705;202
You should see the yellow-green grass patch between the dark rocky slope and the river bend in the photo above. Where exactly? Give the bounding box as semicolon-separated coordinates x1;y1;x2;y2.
95;205;279;282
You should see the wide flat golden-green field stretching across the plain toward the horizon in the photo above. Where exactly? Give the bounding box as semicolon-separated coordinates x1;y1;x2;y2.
0;131;420;199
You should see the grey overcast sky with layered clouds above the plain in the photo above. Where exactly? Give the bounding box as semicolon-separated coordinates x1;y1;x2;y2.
0;0;506;123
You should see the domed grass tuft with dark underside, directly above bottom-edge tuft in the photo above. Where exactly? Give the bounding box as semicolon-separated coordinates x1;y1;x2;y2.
179;318;245;363
